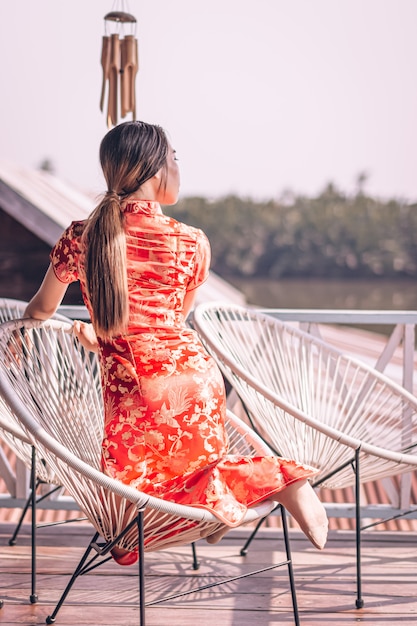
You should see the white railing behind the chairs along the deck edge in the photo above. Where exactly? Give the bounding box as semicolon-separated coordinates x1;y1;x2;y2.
0;307;417;518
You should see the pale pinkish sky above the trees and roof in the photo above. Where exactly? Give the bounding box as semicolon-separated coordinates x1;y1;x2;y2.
0;0;417;201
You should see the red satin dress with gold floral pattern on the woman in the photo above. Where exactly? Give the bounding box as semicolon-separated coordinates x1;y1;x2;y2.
51;201;316;526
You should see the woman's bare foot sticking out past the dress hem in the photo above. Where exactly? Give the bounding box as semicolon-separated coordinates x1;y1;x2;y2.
276;479;329;550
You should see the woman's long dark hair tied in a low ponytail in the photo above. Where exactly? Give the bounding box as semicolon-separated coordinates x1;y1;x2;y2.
84;121;168;338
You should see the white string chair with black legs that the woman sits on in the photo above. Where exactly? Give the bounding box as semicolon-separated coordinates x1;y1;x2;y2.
0;320;299;626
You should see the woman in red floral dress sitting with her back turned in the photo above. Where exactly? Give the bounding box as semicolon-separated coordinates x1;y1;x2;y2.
26;122;327;565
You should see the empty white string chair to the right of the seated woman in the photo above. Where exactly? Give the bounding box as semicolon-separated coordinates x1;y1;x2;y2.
193;303;417;608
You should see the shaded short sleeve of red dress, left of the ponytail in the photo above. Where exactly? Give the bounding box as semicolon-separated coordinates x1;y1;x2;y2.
49;222;80;284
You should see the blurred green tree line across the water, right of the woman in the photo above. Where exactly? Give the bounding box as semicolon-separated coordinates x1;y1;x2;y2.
165;184;417;278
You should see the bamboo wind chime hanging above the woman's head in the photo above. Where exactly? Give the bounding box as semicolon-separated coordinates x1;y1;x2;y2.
100;11;139;128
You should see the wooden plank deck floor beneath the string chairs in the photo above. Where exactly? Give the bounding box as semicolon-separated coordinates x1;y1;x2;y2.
0;524;417;626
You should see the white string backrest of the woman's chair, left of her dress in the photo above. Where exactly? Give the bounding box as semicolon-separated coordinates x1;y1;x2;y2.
2;320;103;469
